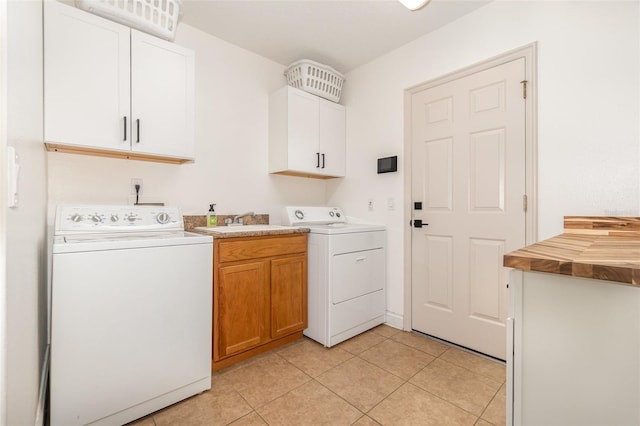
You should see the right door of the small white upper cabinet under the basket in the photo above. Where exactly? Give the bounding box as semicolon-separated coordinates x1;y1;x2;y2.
319;99;346;177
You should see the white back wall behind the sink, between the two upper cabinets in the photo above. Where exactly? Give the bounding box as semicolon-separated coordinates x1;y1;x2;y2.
48;24;326;223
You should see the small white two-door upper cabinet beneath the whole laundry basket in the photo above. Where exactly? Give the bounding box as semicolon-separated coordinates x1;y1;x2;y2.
269;86;346;178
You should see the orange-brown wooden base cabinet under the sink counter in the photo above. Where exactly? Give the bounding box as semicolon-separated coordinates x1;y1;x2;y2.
212;234;307;370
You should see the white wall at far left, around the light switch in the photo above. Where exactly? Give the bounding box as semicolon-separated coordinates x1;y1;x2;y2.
0;0;47;425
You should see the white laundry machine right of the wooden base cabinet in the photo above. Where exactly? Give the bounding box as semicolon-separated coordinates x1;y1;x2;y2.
284;206;387;347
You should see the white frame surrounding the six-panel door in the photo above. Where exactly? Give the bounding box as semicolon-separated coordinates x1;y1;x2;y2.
403;42;538;331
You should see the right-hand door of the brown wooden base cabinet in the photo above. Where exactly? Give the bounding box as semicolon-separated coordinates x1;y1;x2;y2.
271;255;307;339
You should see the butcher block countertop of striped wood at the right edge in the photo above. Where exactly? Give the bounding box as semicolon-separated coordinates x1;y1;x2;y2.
504;216;640;286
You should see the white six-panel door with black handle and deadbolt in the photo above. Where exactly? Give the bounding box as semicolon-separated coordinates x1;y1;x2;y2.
411;59;525;359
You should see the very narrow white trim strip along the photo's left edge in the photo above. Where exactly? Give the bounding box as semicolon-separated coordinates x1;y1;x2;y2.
0;1;7;426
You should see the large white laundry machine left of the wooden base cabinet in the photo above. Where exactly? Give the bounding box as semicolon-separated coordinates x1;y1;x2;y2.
50;205;213;426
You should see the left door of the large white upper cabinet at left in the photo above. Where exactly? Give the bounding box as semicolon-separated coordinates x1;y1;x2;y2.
44;1;130;151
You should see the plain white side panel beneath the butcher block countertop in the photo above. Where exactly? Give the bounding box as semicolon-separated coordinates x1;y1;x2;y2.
520;273;640;426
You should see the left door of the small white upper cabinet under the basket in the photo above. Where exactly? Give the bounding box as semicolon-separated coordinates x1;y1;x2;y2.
288;87;322;174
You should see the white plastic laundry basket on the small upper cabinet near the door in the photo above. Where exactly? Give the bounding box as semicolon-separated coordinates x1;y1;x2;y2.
284;59;344;102
